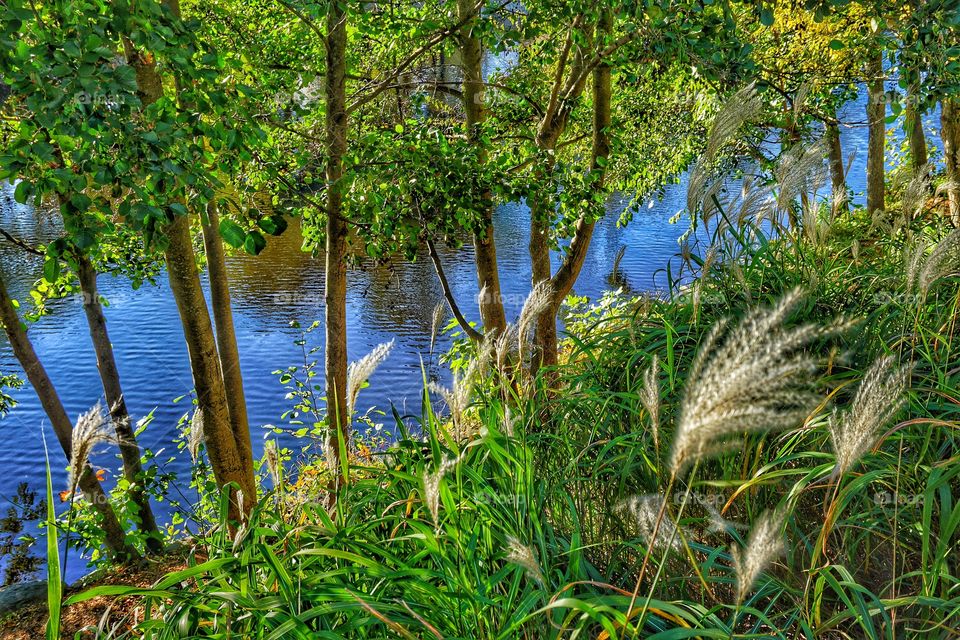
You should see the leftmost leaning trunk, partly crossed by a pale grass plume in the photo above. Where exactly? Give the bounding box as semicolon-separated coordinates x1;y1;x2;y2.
0;278;137;560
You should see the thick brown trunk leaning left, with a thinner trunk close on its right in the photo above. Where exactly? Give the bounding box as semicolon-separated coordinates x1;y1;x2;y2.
166;216;257;522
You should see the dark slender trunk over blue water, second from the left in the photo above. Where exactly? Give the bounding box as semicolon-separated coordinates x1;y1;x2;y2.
77;255;163;553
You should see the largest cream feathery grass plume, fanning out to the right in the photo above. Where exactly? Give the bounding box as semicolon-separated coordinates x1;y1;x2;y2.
670;290;848;474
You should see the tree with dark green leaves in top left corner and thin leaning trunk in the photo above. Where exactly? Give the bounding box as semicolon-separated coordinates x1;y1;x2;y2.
0;2;167;551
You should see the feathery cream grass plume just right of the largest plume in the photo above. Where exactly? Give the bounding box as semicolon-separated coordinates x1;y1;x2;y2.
830;355;910;477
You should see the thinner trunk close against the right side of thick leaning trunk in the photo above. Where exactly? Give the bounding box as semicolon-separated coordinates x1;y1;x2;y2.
202;202;253;469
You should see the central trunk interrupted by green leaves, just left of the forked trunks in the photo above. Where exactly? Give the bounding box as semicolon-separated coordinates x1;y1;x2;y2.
457;0;507;336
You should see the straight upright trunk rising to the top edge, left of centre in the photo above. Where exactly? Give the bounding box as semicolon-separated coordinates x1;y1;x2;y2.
324;2;350;482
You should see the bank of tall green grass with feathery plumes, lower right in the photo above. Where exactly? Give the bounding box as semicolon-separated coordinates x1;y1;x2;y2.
62;194;960;639
